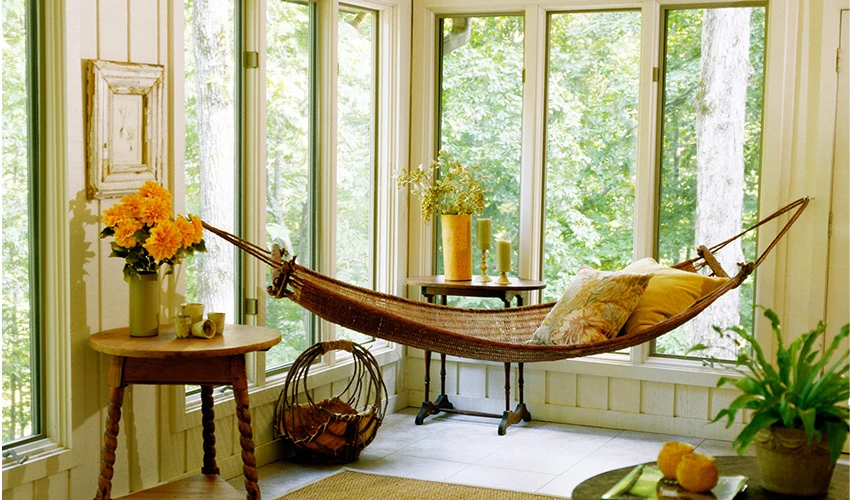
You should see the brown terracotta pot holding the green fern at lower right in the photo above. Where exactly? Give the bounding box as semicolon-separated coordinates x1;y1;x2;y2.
754;426;835;496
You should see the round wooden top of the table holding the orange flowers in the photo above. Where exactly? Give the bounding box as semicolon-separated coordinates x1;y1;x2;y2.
89;325;281;359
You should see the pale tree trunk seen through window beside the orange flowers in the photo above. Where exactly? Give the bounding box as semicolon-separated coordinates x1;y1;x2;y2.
192;0;235;312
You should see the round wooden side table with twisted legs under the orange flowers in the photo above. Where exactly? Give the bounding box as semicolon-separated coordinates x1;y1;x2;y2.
89;325;281;500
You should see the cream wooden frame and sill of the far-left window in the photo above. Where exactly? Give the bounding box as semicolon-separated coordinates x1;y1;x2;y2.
3;2;78;476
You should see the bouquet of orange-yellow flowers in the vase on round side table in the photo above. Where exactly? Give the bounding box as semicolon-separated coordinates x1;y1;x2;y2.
100;181;206;281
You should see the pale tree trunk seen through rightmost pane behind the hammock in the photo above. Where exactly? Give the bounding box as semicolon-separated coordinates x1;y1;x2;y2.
691;8;752;358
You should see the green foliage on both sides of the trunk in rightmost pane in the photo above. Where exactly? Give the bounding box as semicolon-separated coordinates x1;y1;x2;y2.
655;7;765;355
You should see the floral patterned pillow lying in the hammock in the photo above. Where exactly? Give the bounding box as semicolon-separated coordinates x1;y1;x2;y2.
528;266;652;345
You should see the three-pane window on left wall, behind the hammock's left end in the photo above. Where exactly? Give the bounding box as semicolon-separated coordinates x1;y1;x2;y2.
184;0;392;376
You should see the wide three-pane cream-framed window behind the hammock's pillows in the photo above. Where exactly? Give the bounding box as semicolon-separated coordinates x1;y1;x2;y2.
410;0;766;363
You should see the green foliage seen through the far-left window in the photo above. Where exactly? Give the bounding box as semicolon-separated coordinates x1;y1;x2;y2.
0;0;38;443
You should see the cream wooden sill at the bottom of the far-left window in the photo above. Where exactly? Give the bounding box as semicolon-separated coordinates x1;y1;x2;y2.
3;439;81;491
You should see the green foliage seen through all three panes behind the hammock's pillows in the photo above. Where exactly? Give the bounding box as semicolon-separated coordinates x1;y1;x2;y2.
430;8;765;355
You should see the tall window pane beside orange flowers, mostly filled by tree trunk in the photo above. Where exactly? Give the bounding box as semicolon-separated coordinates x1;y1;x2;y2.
184;0;238;321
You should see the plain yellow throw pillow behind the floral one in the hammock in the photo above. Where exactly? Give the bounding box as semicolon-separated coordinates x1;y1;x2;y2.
623;257;729;335
